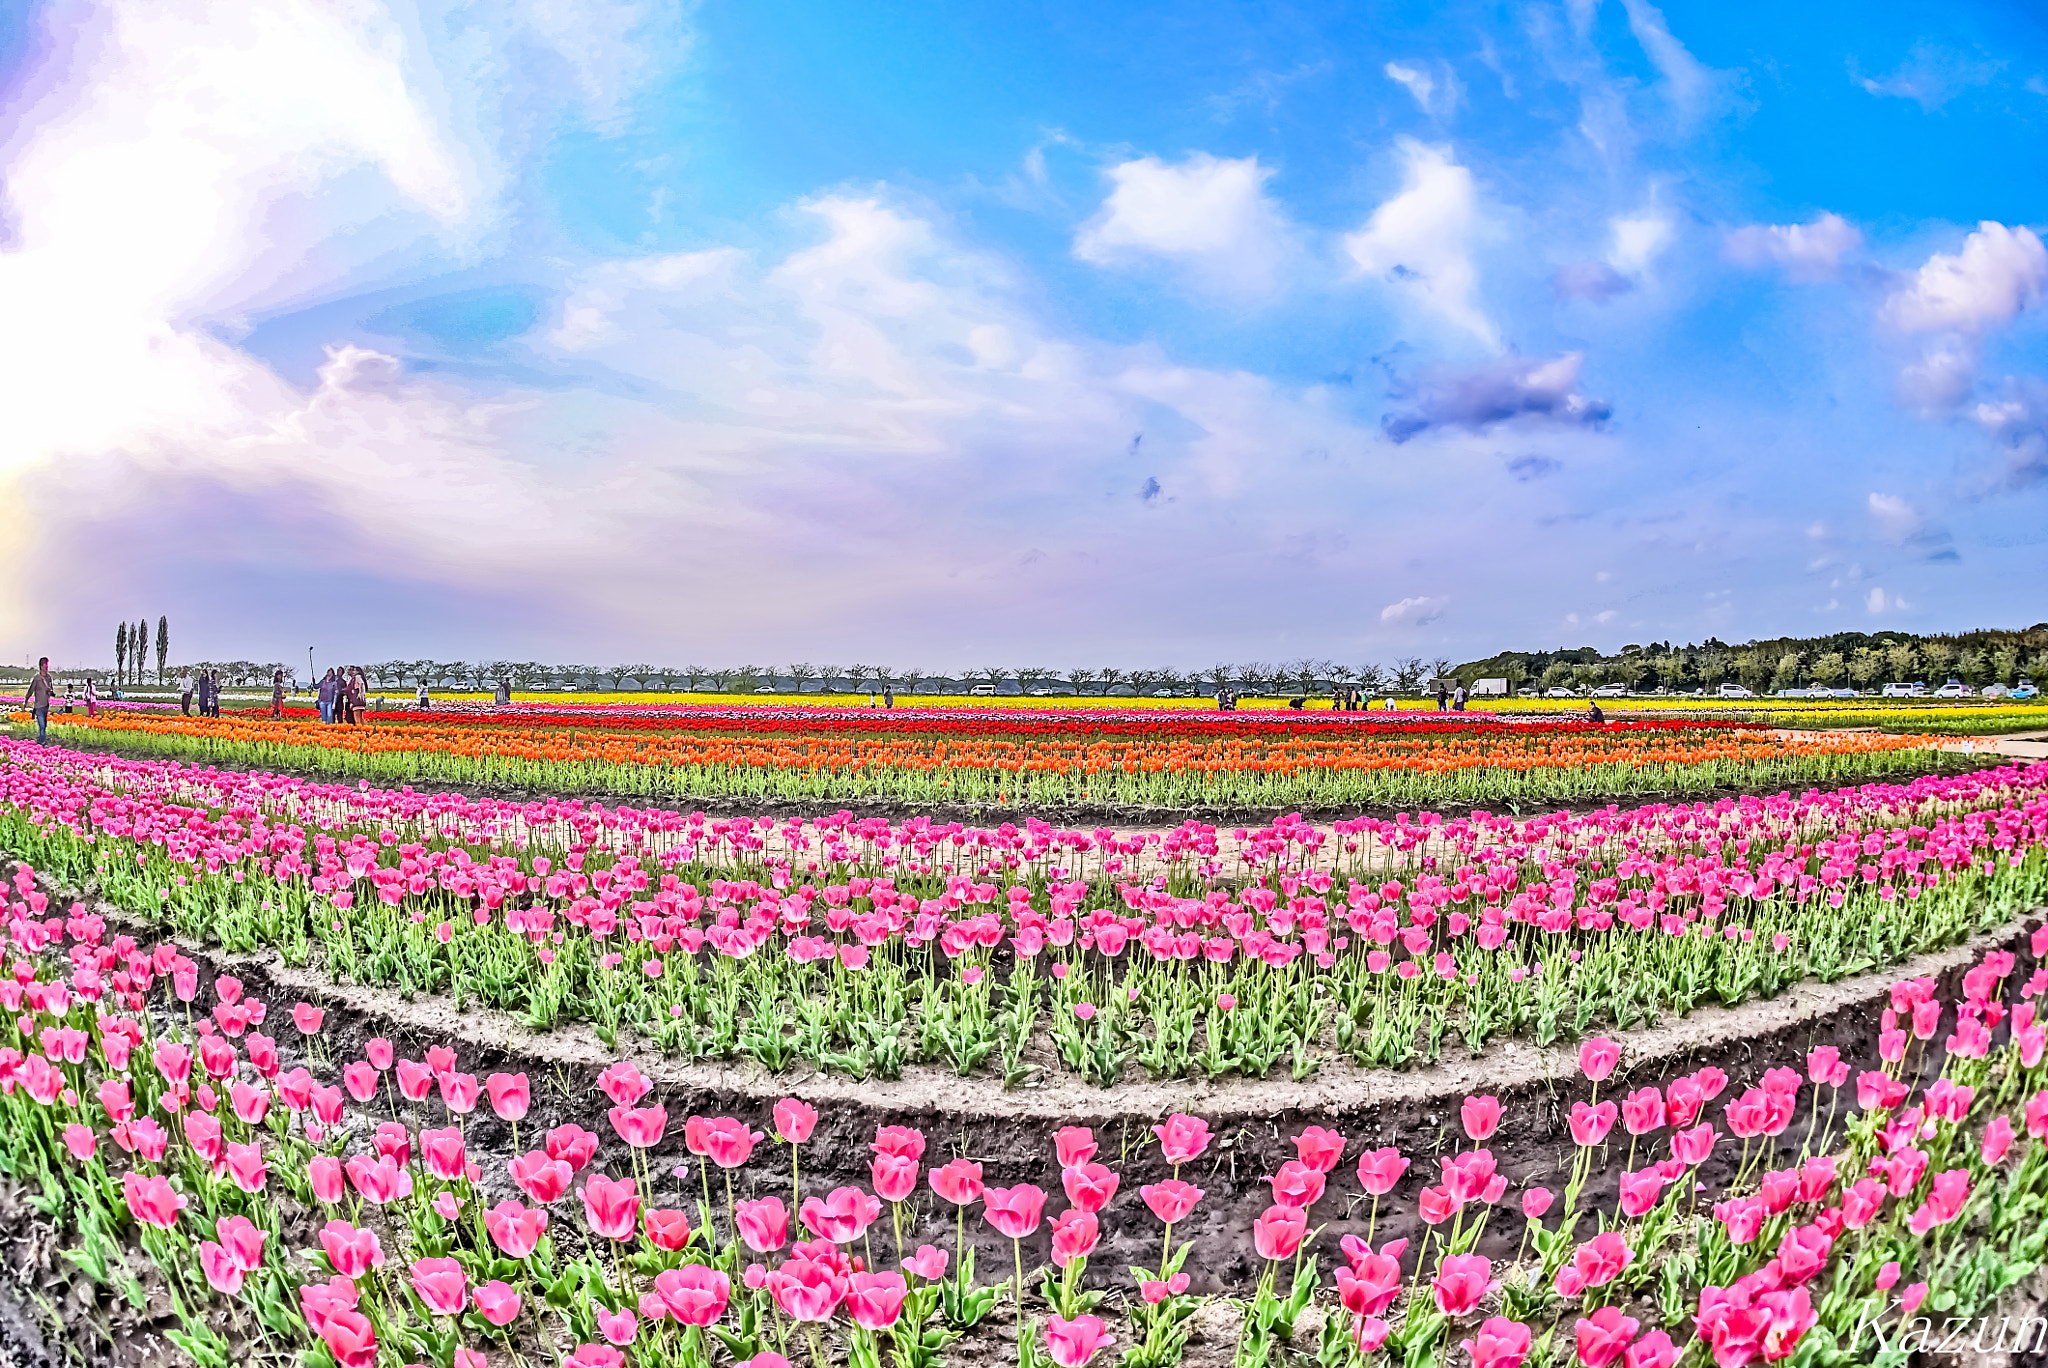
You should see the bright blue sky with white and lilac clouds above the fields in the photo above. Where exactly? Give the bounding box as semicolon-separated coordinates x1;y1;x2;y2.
0;0;2048;672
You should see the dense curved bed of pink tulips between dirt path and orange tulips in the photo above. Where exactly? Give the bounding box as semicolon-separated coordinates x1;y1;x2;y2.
0;741;2048;1085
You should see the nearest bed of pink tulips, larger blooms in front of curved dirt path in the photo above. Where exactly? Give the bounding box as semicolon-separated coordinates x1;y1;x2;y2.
0;839;2048;1368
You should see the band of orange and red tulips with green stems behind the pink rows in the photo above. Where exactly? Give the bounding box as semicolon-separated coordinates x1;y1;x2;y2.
8;707;1974;811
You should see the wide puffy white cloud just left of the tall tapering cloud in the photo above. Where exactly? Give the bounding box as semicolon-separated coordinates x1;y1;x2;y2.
1073;152;1288;295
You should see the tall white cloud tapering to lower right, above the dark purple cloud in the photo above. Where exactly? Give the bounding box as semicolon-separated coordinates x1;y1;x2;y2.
1343;139;1499;346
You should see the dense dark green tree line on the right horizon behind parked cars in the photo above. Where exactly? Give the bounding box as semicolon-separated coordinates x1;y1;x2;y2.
1454;623;2048;692
